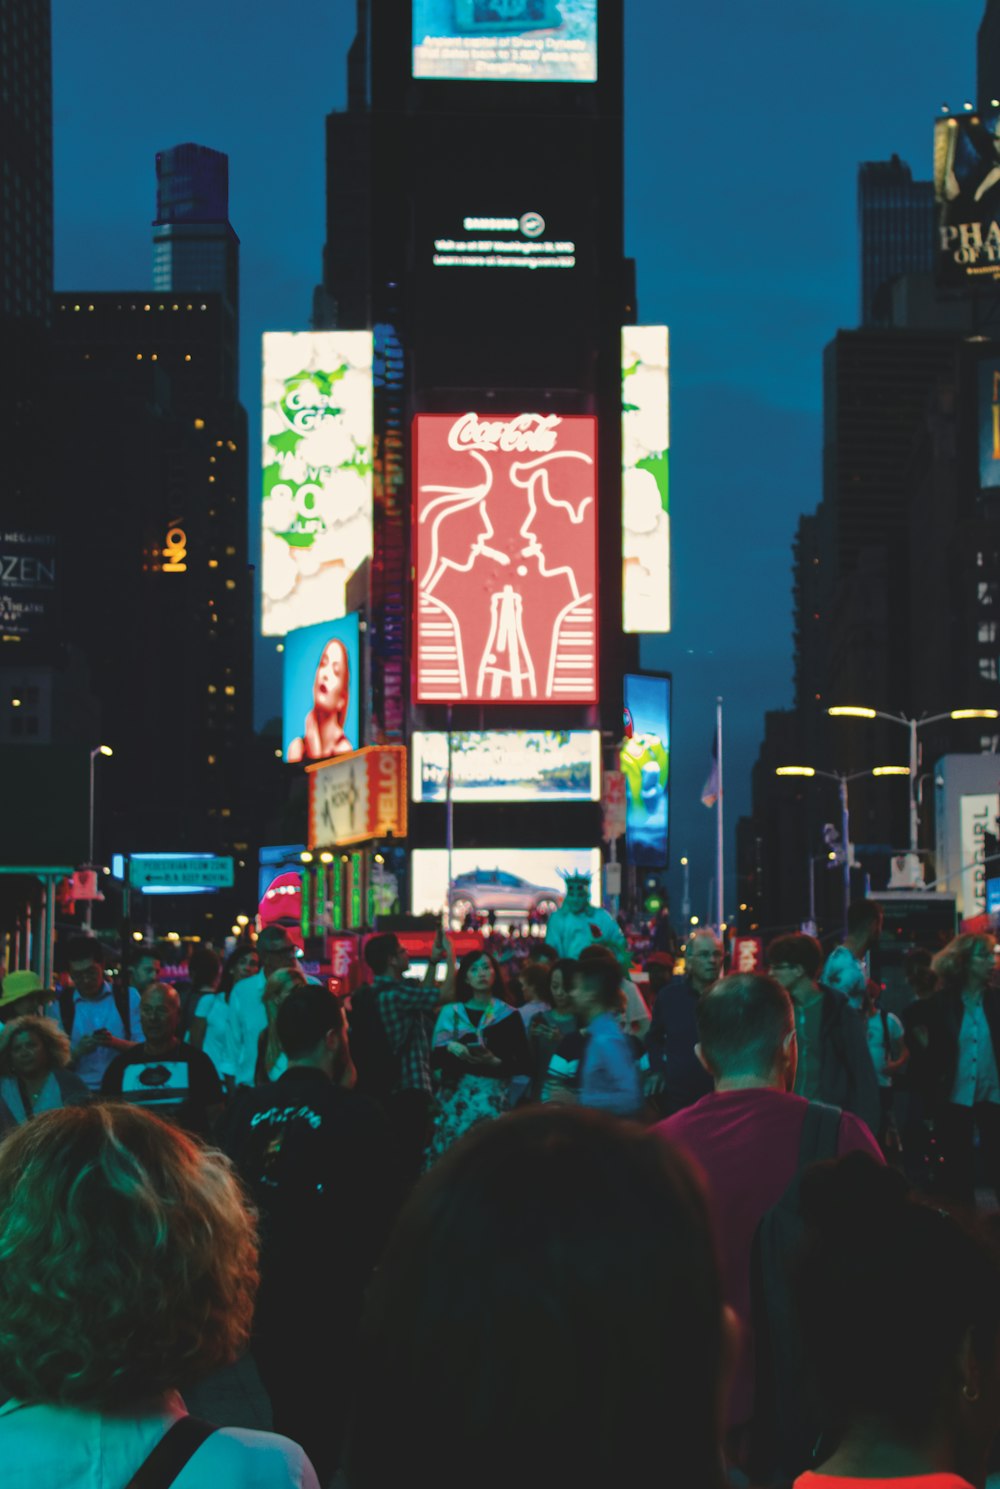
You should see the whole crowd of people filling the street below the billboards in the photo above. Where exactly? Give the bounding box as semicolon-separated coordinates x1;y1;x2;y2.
0;901;1000;1489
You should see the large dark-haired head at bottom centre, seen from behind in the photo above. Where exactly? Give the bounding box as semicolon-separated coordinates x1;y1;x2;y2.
345;1106;728;1489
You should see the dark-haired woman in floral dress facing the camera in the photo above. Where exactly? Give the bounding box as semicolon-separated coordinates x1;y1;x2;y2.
427;951;531;1167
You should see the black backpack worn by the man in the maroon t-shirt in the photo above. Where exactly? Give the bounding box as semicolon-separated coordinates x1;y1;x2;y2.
750;1102;841;1486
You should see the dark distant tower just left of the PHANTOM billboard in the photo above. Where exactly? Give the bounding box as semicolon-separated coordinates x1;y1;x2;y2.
857;155;935;326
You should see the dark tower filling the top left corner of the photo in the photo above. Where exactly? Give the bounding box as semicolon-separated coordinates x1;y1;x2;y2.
0;0;52;322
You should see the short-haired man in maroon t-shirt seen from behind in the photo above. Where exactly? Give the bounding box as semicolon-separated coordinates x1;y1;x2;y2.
656;972;882;1428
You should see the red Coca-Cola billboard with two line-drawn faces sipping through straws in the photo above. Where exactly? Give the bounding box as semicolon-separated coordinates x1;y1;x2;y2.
414;412;597;703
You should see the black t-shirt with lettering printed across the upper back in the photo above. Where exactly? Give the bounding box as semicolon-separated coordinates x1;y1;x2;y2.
223;1066;399;1309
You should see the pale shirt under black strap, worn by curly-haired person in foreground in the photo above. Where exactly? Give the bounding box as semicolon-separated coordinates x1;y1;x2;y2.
0;1391;318;1489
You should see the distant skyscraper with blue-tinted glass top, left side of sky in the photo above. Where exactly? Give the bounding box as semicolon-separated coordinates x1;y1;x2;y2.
153;144;240;393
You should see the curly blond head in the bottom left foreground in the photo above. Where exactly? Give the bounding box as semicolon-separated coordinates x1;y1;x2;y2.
0;1103;257;1410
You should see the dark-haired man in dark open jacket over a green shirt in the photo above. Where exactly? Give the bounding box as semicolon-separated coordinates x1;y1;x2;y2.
766;934;881;1133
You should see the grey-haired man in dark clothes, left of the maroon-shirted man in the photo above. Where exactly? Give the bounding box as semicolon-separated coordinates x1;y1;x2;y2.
646;931;722;1117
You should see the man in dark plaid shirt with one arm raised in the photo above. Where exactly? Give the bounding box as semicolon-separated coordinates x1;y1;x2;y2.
351;929;455;1182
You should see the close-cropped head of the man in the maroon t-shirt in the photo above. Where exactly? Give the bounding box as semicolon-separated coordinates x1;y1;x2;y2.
695;972;796;1091
